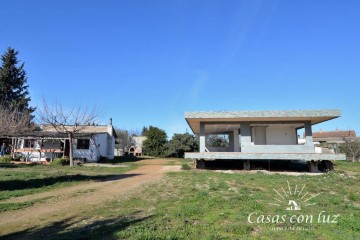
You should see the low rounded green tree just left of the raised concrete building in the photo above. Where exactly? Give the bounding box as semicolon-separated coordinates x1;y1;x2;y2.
166;133;199;158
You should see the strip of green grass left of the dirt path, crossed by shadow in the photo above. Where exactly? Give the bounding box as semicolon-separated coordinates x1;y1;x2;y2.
0;163;136;200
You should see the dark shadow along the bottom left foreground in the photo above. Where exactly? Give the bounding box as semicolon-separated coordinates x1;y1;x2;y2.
0;213;151;240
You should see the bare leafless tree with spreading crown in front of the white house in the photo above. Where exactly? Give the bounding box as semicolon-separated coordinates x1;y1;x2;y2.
37;99;100;166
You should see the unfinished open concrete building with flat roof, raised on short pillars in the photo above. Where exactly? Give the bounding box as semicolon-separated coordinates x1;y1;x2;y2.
185;110;346;171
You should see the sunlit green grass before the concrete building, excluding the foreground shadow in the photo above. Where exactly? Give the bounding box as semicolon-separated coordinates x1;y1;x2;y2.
107;171;360;239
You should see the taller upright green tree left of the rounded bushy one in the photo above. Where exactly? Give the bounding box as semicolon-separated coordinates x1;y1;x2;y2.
143;126;167;157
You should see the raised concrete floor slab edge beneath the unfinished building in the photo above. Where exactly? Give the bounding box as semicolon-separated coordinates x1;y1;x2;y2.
185;152;346;161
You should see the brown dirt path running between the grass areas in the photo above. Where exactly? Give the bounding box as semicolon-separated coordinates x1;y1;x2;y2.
0;159;180;235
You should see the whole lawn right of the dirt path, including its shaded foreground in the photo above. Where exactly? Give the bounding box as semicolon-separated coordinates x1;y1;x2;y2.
2;162;360;240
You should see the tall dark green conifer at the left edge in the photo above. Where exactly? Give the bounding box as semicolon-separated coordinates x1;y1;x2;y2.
0;48;35;114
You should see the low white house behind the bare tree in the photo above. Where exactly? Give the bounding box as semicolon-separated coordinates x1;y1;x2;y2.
14;121;116;162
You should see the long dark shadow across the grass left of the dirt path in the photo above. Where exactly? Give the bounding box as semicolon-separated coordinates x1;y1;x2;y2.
0;174;139;191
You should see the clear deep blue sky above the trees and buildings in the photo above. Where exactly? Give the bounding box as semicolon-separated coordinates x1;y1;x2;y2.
0;0;360;136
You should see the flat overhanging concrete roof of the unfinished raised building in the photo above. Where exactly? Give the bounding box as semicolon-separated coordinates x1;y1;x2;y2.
185;110;341;134
